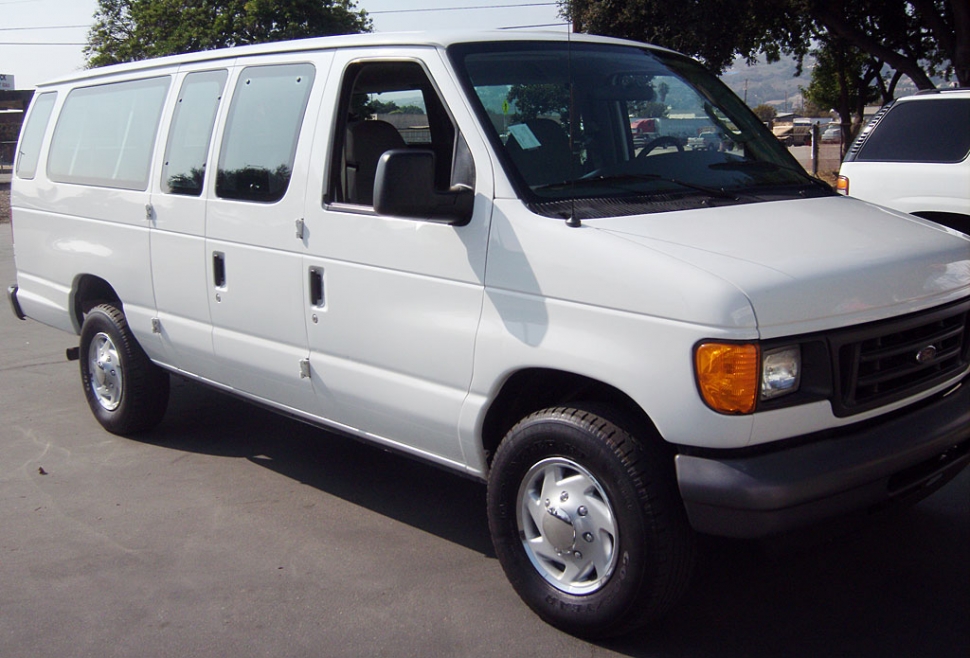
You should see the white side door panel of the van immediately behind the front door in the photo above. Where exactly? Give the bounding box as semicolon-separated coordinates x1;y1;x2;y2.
205;52;332;410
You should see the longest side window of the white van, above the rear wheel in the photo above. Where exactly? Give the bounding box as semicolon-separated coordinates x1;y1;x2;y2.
47;76;170;190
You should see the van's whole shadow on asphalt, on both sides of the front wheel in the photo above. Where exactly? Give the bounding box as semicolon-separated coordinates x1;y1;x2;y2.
141;378;970;658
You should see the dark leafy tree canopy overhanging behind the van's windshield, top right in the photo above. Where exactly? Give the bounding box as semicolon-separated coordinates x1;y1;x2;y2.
560;0;970;89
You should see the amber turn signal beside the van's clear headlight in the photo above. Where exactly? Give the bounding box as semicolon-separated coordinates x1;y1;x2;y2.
694;343;761;414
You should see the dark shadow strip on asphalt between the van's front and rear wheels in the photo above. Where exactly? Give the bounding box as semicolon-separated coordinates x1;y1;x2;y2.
139;377;494;557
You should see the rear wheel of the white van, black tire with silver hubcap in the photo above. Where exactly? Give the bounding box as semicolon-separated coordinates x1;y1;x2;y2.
79;304;169;436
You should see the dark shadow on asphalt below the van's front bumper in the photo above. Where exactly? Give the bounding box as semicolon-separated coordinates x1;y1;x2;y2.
602;502;970;658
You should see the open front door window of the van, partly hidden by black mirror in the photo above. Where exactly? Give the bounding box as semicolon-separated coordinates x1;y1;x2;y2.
326;61;466;206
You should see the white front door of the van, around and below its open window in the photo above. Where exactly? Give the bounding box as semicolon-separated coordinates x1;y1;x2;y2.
304;48;492;467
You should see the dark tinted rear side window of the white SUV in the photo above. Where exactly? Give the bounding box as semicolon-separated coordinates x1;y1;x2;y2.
855;98;970;163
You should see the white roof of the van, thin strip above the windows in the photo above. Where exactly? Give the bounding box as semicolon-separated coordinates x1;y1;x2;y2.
38;30;666;89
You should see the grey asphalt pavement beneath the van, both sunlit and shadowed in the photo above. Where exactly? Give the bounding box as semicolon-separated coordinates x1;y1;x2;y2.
0;213;970;658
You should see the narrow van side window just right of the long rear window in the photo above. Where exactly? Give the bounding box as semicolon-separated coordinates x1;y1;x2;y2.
162;71;229;196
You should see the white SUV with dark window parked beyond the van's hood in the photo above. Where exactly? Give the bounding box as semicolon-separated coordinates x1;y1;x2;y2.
838;89;970;234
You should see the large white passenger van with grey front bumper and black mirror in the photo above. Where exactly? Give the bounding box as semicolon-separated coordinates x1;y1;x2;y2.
9;32;970;636
